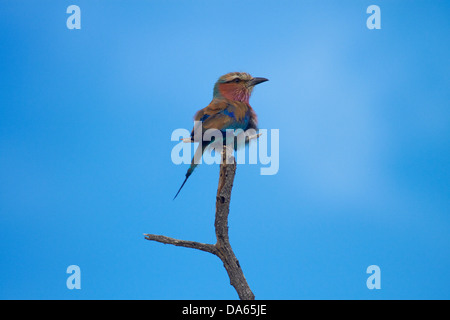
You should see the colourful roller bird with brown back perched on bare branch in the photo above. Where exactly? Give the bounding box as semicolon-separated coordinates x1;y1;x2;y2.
174;72;268;199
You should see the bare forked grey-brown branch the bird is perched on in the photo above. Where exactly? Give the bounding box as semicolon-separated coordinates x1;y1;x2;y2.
144;145;255;300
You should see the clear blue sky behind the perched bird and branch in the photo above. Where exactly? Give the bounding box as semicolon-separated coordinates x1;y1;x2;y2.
0;0;450;299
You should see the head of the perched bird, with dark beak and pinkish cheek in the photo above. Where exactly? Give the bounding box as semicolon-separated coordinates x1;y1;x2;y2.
214;72;268;103
